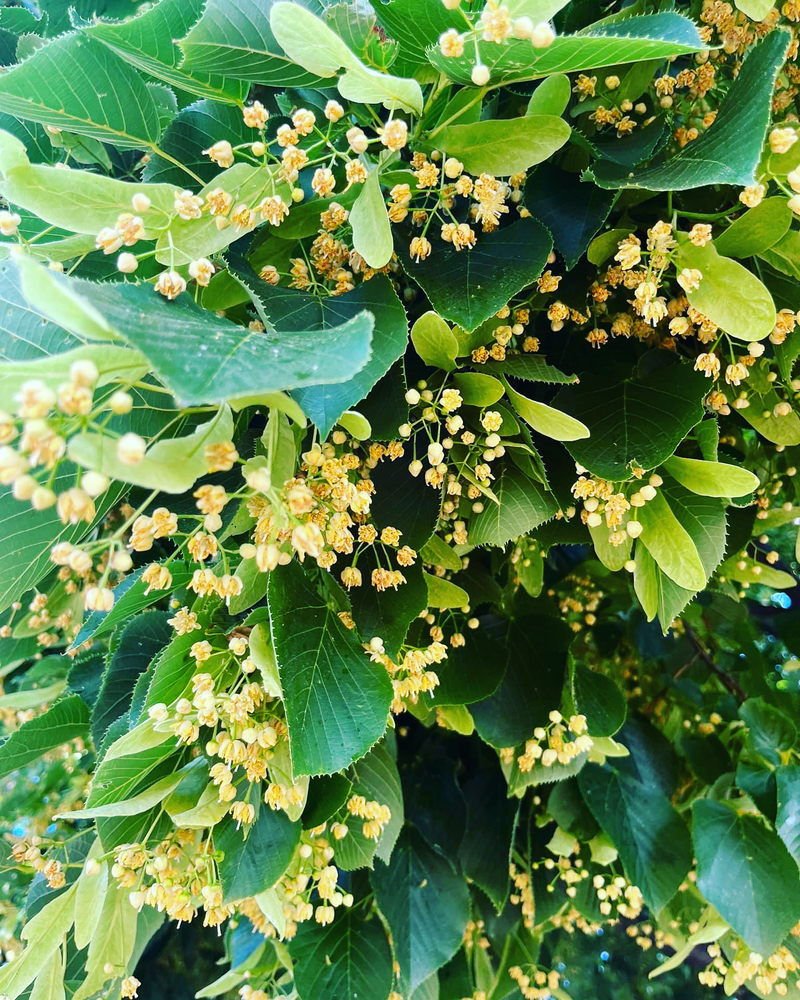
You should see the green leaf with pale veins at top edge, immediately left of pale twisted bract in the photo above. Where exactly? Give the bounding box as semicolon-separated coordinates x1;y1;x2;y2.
179;0;321;87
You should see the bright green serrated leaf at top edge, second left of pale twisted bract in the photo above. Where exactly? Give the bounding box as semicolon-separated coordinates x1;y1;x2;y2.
84;0;248;105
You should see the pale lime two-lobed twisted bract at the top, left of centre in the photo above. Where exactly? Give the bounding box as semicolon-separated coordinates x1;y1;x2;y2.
270;3;423;115
